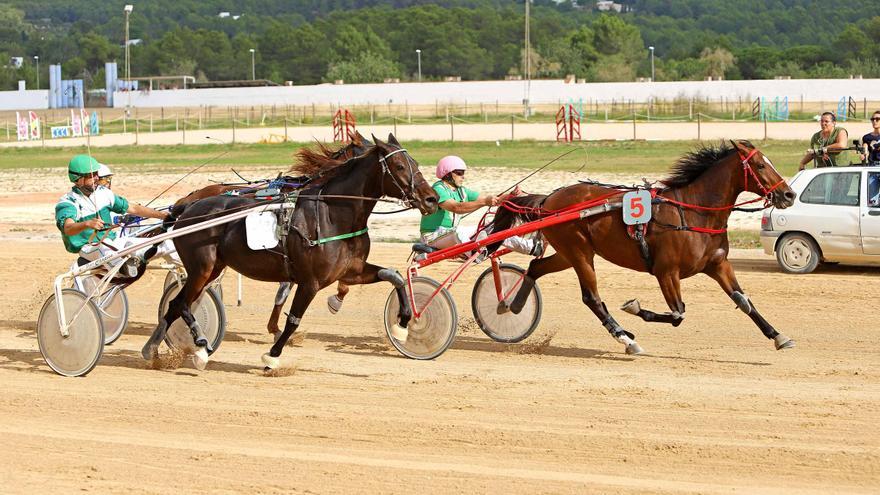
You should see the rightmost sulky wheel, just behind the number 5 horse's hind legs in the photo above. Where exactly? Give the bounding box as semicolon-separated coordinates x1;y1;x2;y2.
471;264;541;343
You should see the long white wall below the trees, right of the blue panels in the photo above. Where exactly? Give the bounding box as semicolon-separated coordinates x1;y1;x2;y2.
113;79;880;108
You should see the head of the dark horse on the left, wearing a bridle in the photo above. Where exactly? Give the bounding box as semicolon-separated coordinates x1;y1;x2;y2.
373;134;438;215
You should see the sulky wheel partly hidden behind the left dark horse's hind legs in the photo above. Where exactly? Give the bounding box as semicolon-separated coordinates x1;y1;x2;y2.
159;284;226;354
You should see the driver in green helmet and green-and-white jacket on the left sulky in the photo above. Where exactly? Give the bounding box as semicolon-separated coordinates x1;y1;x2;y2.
55;155;169;278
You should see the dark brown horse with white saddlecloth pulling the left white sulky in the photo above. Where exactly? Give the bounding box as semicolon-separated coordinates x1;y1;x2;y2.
142;135;437;368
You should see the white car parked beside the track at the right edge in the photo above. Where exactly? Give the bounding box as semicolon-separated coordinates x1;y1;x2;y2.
761;166;880;273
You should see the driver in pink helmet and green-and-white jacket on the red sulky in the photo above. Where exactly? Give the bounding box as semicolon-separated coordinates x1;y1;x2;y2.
420;155;543;256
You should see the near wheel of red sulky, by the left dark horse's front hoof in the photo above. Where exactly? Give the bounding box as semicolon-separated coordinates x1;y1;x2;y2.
385;277;458;359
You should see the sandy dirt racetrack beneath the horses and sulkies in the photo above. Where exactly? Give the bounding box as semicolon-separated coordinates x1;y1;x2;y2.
0;167;880;494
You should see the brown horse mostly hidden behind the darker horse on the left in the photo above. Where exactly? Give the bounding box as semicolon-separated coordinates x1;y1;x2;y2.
174;132;373;337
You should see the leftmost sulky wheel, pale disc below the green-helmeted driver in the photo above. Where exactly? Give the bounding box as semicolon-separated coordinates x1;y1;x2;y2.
37;289;104;376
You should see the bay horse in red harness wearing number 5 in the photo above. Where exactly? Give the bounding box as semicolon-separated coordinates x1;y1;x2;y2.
489;141;795;354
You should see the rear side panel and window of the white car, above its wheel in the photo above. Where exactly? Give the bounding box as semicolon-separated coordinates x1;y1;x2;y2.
792;167;862;256
